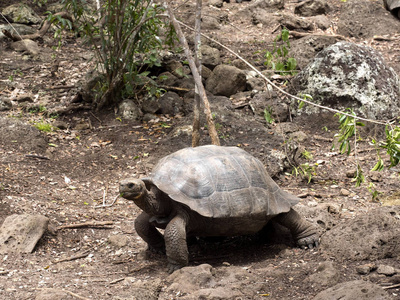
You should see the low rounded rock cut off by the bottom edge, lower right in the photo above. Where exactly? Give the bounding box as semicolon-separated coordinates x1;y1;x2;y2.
313;280;391;300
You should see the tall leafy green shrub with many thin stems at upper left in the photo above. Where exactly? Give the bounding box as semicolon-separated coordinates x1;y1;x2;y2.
61;0;174;109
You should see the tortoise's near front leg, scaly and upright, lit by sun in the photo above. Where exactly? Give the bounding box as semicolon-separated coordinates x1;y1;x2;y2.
164;214;189;274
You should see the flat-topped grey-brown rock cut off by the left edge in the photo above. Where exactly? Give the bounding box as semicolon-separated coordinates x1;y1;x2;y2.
0;215;49;254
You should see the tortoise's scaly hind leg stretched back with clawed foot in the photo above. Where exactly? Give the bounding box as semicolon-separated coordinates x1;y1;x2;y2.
273;209;319;249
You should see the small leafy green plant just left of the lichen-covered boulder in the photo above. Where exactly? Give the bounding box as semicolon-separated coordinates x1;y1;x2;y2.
264;28;297;75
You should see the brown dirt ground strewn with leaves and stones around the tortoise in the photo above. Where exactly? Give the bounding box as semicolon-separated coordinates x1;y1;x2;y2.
0;0;400;299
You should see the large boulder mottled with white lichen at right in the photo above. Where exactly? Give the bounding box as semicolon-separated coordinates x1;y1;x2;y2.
292;42;400;119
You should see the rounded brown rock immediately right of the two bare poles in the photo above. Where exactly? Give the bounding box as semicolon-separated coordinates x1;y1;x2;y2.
206;65;246;97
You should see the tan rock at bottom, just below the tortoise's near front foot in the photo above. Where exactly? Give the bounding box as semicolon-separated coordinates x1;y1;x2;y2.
167;264;215;293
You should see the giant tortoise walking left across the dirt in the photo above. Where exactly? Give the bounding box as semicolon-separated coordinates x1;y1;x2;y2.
120;145;319;273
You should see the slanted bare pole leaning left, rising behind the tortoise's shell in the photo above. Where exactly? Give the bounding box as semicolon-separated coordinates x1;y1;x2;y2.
164;1;220;146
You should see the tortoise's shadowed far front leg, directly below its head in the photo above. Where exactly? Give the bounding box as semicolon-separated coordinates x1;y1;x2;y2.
135;212;165;253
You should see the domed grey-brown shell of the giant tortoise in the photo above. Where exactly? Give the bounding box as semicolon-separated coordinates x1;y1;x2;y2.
151;145;299;218
